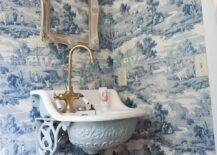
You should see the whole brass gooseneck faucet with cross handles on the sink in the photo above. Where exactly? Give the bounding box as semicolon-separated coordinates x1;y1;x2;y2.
54;44;93;113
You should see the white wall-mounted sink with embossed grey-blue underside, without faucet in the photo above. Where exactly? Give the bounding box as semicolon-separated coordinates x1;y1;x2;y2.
31;89;148;154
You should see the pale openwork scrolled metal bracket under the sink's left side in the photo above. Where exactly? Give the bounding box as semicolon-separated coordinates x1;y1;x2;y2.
36;118;70;155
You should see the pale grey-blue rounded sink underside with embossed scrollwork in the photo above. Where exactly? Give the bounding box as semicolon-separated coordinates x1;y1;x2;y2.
67;118;137;154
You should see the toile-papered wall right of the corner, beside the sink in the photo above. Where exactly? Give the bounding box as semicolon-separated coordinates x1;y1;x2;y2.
104;0;215;154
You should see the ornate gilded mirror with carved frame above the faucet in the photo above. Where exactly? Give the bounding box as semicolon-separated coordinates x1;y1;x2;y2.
41;0;99;50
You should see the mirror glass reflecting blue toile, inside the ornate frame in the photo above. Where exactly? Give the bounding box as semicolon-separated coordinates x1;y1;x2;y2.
50;0;89;37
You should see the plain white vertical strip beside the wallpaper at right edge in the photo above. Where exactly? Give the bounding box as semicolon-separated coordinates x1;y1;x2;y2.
202;0;217;151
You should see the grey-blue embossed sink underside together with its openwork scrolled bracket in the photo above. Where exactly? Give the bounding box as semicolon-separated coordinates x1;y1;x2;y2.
36;118;137;155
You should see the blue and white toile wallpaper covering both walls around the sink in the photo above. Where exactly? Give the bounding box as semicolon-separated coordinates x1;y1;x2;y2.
0;0;215;155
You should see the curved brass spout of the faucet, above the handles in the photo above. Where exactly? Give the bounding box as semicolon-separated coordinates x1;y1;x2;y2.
67;44;93;91
